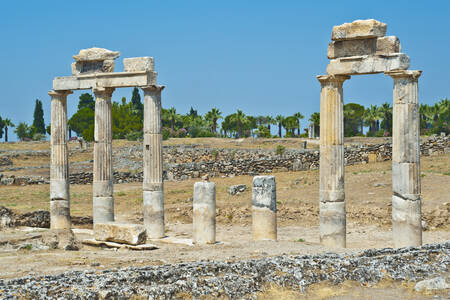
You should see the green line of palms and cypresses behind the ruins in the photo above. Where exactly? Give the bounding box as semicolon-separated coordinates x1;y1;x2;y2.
0;88;450;141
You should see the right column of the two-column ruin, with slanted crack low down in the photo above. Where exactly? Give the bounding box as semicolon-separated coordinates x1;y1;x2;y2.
386;71;422;247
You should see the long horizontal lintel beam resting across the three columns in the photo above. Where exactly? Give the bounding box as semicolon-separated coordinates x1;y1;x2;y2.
53;71;156;91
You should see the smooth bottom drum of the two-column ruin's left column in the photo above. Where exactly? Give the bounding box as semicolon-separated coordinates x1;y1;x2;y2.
319;202;347;248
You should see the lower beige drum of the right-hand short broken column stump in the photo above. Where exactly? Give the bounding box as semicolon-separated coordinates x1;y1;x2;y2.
252;206;277;241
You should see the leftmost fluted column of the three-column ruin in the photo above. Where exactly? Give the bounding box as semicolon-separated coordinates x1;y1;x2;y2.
48;91;72;229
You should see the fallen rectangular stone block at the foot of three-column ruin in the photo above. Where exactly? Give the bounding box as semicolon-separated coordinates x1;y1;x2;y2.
94;223;147;245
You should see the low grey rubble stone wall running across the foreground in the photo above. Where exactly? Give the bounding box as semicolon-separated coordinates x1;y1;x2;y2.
0;242;450;299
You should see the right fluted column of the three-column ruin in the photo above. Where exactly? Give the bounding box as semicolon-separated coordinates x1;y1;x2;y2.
142;85;164;239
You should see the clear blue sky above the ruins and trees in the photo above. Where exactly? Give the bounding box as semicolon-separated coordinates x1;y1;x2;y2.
0;0;450;138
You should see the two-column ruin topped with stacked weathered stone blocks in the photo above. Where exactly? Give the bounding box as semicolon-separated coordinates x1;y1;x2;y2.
317;20;422;247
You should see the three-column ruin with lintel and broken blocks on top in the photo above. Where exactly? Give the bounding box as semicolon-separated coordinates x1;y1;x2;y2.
49;48;164;238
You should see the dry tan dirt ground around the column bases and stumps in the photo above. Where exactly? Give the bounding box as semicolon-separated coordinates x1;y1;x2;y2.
0;154;450;278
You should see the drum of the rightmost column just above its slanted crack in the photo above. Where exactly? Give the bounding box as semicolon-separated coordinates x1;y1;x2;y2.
392;162;420;196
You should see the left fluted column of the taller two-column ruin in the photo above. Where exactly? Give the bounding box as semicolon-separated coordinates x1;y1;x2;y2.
317;75;350;248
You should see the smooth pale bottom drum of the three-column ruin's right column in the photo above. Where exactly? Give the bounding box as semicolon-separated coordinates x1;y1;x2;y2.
143;191;165;239
